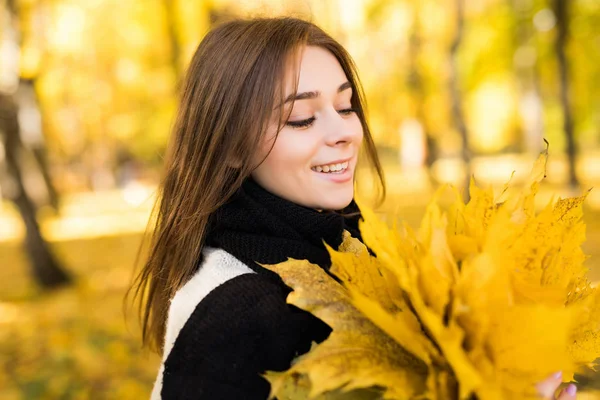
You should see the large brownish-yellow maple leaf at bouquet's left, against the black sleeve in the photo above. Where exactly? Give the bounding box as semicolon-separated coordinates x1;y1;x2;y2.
265;260;427;398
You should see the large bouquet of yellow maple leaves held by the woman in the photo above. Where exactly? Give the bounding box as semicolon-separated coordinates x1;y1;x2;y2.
265;152;600;400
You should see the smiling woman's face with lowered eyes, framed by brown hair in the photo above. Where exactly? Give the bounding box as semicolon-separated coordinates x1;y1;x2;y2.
252;46;363;210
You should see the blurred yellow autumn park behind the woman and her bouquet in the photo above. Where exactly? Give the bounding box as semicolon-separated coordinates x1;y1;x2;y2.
0;0;600;399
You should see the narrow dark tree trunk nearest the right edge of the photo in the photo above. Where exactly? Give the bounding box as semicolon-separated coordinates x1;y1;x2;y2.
554;0;579;187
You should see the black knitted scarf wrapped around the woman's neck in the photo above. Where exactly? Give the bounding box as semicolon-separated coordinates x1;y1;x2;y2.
206;178;361;275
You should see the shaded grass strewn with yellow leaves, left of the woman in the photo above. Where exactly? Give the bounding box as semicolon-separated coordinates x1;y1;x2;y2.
0;235;159;400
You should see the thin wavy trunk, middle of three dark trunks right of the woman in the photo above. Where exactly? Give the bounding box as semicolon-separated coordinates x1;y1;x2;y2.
449;0;472;201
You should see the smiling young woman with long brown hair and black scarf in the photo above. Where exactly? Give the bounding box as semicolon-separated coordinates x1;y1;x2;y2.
130;18;576;400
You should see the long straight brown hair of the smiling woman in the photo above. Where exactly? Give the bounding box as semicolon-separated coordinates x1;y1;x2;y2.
126;18;385;349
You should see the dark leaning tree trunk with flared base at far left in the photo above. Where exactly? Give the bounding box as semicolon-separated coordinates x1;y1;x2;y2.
0;93;70;288
